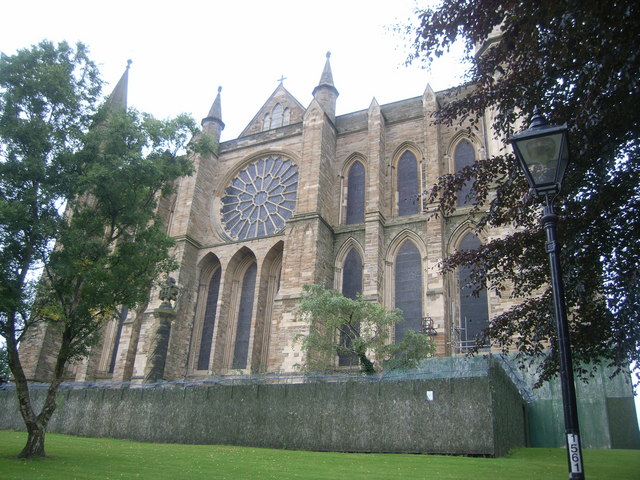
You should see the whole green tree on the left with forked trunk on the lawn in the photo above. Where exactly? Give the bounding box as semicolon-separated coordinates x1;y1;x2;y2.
0;42;195;458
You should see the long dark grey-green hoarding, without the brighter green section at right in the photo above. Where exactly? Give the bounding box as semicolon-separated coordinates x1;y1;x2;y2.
0;358;526;456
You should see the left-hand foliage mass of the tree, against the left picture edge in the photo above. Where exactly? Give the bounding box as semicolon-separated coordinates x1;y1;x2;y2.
0;41;101;333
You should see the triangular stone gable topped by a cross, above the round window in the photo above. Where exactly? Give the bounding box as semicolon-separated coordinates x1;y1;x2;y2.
239;84;305;137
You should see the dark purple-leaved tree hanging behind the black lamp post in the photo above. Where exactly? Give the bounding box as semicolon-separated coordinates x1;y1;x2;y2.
405;0;640;379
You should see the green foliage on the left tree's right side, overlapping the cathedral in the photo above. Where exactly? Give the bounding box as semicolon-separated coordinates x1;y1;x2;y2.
39;110;195;352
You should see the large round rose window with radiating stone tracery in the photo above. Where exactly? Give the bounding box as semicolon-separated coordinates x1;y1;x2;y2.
220;156;298;240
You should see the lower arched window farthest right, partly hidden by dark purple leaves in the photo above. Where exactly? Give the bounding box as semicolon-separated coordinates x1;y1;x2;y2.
458;233;489;352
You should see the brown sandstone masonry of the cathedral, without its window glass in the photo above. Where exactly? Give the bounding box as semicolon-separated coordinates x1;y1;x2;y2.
21;67;528;388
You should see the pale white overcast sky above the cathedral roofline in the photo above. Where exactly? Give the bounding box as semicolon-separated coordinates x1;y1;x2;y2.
0;0;463;140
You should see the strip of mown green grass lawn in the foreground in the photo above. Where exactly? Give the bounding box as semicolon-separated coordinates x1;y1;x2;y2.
0;431;640;480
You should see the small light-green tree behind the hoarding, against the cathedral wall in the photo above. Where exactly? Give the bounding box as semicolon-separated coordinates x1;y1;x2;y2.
297;285;435;375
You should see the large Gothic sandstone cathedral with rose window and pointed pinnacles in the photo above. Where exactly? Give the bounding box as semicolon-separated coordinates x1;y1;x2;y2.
23;54;511;382
